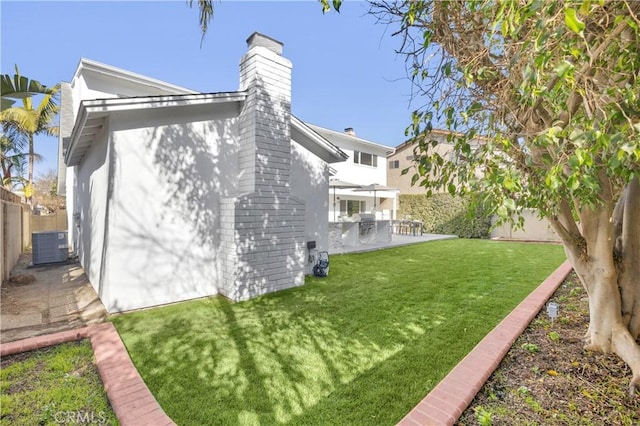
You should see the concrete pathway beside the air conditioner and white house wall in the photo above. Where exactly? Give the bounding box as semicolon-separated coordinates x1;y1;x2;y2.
0;253;107;343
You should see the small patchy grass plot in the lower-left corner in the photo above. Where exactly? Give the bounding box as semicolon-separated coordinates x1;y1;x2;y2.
0;341;118;425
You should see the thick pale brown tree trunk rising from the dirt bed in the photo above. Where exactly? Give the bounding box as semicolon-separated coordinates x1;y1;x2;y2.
552;191;640;396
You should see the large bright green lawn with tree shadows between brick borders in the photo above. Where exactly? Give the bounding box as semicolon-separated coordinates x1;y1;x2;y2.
113;240;564;425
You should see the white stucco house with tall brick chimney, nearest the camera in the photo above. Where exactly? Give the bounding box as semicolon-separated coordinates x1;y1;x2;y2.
59;33;347;312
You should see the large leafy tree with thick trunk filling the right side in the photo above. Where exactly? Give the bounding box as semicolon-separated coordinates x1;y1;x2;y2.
371;0;640;394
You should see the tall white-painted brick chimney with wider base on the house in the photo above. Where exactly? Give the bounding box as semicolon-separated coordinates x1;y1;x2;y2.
220;33;306;300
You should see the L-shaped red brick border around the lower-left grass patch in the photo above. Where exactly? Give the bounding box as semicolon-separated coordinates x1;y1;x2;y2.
0;322;175;426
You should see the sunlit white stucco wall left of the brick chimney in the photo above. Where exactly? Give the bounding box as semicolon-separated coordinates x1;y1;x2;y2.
107;116;237;312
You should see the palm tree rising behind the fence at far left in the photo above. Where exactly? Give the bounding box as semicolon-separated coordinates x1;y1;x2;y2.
0;66;60;200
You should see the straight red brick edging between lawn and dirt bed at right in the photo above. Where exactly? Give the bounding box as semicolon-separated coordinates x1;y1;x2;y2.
398;261;573;426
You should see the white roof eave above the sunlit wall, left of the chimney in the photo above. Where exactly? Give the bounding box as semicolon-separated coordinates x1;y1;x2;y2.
64;92;247;166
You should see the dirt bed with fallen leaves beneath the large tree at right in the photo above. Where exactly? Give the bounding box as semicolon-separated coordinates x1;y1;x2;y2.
458;274;640;425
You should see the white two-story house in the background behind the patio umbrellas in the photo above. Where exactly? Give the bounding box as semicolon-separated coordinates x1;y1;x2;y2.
308;124;397;221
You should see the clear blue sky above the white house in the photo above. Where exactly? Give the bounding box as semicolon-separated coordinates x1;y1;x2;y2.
0;0;418;176
